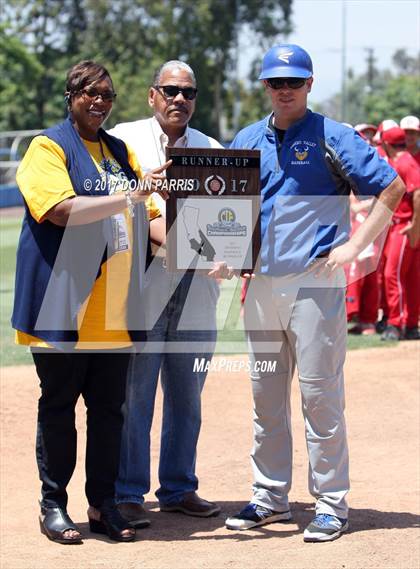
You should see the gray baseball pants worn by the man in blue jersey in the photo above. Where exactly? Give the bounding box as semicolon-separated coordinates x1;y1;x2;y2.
245;263;349;518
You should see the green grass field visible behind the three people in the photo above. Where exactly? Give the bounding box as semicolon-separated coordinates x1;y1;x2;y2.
0;213;393;366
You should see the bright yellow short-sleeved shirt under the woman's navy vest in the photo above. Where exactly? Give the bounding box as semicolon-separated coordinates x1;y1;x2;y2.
16;136;160;349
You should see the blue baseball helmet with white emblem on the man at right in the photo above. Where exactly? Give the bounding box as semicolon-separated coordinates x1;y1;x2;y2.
258;43;313;79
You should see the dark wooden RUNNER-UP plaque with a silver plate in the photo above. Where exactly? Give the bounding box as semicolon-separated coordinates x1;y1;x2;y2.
166;147;261;271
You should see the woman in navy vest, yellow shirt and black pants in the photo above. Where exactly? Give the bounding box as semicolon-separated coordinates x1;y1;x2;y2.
12;61;168;544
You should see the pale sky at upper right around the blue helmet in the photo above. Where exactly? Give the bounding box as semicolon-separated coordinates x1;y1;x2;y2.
240;0;420;102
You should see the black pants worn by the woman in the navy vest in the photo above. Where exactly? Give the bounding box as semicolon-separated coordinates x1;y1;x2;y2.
32;350;129;508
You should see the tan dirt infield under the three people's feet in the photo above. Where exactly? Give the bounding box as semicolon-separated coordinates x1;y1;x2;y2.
0;342;420;569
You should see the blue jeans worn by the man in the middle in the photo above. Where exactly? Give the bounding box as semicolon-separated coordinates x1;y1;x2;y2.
116;264;218;504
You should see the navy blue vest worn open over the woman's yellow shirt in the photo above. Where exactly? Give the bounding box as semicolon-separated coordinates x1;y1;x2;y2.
12;118;149;349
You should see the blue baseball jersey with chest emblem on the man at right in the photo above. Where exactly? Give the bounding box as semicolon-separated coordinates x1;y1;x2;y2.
231;110;397;276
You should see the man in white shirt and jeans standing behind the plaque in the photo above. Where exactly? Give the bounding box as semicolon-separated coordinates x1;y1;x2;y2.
111;61;221;528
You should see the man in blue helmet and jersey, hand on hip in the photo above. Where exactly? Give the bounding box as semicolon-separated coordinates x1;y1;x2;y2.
226;44;405;541
